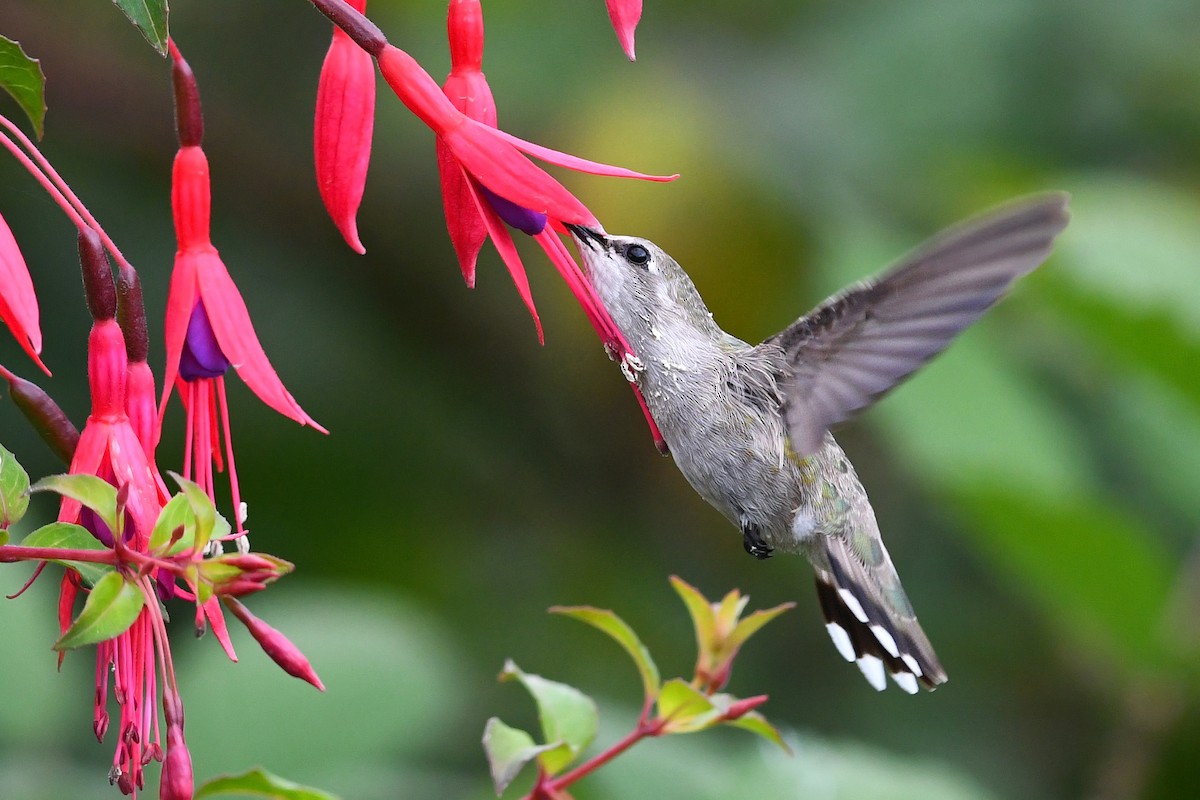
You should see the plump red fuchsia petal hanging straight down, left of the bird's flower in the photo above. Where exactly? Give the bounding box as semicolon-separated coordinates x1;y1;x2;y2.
313;16;376;253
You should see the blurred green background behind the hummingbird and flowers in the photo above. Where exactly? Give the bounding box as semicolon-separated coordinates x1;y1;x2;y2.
0;0;1200;800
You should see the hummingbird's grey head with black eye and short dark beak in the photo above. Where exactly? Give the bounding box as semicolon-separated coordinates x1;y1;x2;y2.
566;224;712;337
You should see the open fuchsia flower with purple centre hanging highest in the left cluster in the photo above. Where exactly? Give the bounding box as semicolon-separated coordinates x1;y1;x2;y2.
158;42;326;534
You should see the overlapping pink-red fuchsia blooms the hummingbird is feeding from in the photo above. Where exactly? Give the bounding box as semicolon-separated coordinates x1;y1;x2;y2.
312;0;678;452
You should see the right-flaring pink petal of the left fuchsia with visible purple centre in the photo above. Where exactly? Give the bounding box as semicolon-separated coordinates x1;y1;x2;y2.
196;251;329;433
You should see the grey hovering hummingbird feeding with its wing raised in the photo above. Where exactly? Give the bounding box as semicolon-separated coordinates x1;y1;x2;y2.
566;193;1069;694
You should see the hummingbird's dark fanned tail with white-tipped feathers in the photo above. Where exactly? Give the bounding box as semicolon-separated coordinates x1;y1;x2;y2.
816;536;946;694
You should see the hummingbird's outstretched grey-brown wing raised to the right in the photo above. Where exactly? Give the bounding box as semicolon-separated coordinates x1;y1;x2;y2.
764;193;1069;456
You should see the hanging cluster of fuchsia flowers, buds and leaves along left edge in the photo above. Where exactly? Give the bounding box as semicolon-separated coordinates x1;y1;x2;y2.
0;31;323;800
